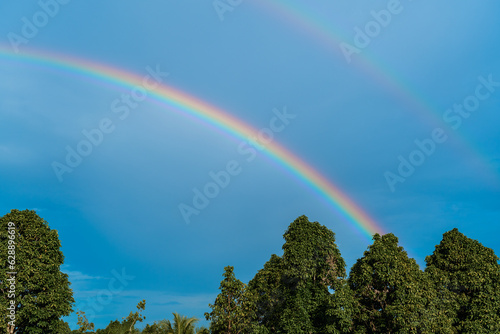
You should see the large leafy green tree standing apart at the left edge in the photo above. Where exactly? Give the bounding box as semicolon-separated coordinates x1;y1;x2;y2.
0;210;74;334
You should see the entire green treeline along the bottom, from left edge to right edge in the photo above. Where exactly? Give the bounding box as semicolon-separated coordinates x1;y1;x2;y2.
0;210;500;334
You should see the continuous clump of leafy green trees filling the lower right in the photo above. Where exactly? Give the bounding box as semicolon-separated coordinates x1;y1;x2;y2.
207;216;500;334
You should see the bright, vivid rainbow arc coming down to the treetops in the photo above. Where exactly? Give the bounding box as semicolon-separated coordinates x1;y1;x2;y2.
0;46;384;241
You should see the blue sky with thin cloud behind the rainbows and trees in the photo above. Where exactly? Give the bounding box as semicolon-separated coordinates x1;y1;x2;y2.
0;0;500;328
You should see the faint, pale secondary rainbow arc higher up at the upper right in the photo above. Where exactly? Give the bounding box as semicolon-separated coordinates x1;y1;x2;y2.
252;0;500;177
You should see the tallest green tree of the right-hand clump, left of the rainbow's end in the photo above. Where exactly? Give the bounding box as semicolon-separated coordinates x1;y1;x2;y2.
249;216;352;333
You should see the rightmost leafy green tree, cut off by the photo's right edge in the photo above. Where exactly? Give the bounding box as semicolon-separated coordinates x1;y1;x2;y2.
425;228;500;333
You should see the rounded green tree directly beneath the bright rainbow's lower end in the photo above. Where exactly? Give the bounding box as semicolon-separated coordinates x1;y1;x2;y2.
348;233;452;333
